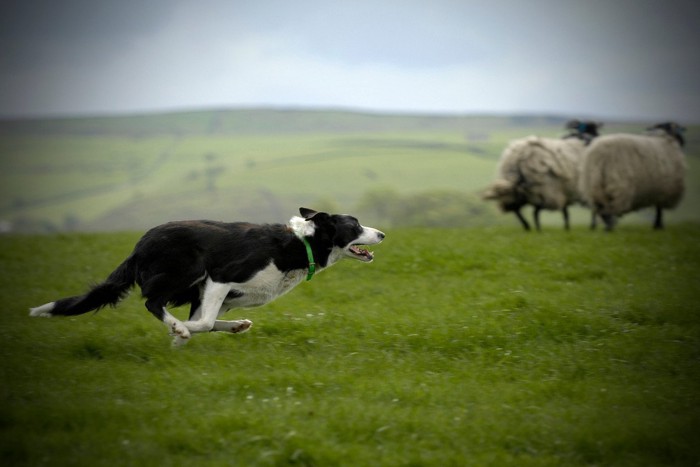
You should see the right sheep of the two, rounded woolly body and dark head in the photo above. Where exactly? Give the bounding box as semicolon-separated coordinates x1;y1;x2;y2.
579;122;686;231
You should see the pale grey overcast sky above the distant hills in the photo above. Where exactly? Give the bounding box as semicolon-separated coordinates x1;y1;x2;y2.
0;0;700;123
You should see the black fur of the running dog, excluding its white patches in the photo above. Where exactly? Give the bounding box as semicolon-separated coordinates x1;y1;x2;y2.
41;208;374;320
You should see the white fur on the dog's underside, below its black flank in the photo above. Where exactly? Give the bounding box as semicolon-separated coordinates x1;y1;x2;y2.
224;261;306;308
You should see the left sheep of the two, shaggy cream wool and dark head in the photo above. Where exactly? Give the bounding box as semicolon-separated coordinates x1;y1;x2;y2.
482;120;602;231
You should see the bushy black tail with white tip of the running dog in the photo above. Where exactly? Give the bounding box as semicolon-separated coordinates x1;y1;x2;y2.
29;256;136;317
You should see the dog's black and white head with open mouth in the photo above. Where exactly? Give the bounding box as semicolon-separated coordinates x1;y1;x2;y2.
290;208;385;266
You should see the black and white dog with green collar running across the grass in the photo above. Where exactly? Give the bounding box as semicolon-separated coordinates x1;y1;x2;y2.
30;208;384;345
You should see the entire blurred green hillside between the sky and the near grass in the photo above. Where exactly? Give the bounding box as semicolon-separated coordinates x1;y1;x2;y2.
0;109;700;232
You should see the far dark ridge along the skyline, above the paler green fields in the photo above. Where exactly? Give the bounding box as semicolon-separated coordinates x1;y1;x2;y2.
0;109;592;137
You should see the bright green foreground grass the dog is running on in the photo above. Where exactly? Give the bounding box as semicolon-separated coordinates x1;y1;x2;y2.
0;224;700;466
